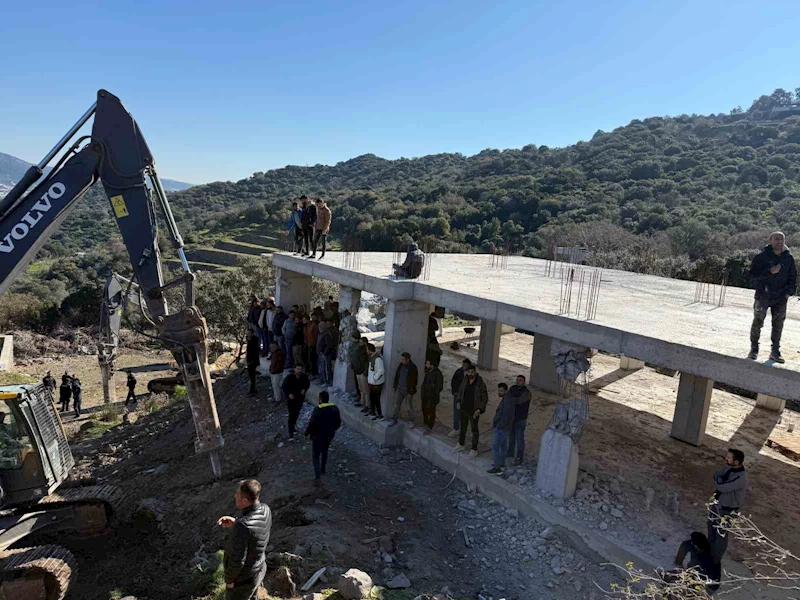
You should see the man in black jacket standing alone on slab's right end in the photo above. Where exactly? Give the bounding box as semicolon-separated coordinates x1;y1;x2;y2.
747;231;797;363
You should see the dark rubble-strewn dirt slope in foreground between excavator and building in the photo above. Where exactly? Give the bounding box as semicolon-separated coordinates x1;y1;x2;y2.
20;372;613;600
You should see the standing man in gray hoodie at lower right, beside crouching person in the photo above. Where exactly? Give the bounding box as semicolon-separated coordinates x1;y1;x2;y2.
708;448;747;562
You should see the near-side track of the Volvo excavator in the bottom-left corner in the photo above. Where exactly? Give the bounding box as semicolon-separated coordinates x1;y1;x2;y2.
0;544;77;600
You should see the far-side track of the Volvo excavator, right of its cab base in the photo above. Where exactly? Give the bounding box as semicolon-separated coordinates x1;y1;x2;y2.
37;485;128;534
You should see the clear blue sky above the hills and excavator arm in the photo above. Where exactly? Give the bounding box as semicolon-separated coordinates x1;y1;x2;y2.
0;0;800;183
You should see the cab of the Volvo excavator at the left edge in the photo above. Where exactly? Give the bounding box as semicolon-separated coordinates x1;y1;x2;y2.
0;384;75;508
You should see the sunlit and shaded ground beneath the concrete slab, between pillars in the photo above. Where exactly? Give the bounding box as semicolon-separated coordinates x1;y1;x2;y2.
428;329;800;564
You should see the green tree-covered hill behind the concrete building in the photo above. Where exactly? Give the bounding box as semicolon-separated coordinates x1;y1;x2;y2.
171;89;800;264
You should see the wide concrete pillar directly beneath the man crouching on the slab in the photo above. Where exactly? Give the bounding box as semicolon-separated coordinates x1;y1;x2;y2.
381;300;430;418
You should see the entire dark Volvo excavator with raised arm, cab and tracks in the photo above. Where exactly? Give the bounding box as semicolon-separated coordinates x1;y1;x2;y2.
0;90;224;600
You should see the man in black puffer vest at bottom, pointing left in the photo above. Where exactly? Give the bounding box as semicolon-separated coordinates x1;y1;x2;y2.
217;479;272;600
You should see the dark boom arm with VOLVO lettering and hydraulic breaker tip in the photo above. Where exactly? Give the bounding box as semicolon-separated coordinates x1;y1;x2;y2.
0;90;223;476
